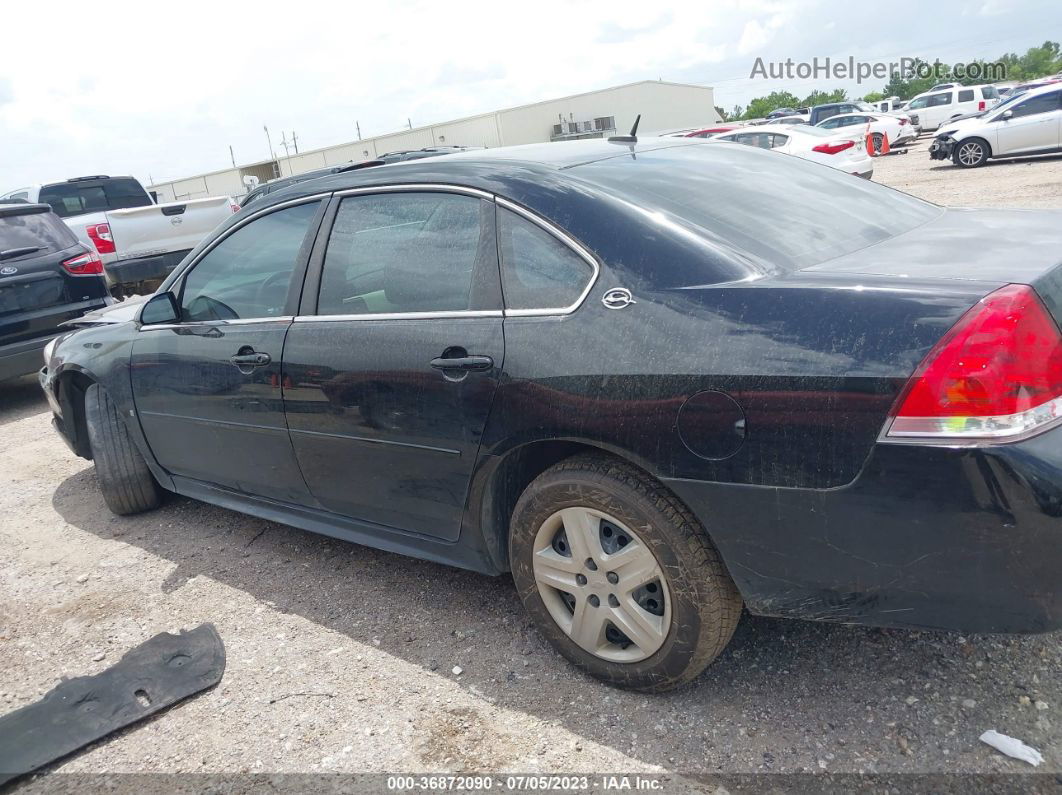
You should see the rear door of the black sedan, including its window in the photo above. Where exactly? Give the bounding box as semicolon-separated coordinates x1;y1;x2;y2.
284;189;504;540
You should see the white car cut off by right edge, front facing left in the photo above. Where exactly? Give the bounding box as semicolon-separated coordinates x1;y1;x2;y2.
929;83;1062;169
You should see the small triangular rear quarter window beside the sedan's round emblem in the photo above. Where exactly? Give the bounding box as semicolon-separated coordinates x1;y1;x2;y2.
498;207;594;310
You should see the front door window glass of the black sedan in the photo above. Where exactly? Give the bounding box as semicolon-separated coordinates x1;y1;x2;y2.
181;202;320;322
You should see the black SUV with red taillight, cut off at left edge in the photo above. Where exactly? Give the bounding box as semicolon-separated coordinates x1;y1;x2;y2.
0;202;112;381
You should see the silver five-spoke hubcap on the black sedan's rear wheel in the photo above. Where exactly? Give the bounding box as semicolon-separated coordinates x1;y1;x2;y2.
532;507;671;662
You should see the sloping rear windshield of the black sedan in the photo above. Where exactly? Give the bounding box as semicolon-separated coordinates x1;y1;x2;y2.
572;145;942;270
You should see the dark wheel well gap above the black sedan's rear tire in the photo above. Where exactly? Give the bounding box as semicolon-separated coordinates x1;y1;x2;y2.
481;439;652;571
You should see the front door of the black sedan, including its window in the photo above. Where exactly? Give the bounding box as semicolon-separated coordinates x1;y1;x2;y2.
131;200;323;504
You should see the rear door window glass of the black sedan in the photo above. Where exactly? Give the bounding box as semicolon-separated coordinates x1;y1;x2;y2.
318;192;484;315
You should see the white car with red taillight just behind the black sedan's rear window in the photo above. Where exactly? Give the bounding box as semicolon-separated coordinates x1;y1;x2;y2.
707;124;874;179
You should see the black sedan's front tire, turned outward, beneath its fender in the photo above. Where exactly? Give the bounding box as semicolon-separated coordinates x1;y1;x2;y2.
85;384;161;516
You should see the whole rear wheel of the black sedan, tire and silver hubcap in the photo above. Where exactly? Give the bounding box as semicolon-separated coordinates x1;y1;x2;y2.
510;454;741;691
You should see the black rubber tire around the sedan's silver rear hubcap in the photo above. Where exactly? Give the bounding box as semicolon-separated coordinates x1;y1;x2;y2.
510;454;742;692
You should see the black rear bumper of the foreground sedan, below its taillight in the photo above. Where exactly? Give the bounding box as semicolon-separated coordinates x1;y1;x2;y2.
669;428;1062;633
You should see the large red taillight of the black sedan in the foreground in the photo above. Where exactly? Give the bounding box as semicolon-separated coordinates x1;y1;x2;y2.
888;284;1062;439
